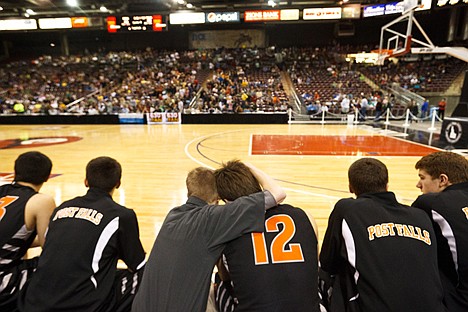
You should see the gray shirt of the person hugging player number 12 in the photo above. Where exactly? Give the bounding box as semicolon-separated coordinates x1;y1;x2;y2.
132;191;270;312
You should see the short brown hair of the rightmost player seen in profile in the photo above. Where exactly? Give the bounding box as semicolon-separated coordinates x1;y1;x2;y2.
414;151;468;184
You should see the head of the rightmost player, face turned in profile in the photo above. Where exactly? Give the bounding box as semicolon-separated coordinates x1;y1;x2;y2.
415;152;468;194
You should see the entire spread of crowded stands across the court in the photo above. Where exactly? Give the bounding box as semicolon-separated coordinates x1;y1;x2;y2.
0;45;466;115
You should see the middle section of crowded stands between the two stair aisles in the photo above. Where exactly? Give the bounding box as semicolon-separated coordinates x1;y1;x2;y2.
196;49;289;113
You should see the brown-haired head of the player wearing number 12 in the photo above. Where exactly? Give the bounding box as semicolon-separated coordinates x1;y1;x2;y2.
215;160;262;201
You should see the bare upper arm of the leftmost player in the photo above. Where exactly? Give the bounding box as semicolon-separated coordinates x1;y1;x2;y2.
24;193;56;247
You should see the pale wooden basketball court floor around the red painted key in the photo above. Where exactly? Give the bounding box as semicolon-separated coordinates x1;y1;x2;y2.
0;124;442;252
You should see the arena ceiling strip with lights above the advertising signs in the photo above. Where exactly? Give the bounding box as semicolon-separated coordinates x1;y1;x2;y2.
0;0;395;18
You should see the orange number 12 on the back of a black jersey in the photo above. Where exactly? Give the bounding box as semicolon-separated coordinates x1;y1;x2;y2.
251;214;304;265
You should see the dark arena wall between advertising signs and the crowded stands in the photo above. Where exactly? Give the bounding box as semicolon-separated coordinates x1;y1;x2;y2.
0;9;451;58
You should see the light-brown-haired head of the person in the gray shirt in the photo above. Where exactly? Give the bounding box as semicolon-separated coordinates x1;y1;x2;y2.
185;167;218;204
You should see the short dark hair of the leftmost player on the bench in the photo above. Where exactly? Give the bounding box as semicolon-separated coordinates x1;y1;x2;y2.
15;151;52;185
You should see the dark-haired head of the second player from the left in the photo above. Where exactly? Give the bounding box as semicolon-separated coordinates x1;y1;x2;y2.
85;156;122;192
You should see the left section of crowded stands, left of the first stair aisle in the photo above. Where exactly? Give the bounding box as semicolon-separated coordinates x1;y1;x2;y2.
0;49;207;115
